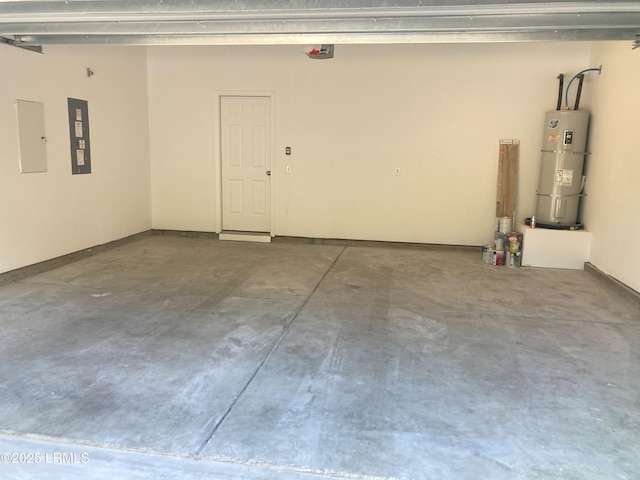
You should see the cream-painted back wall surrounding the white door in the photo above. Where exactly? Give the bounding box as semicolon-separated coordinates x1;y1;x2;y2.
148;43;590;245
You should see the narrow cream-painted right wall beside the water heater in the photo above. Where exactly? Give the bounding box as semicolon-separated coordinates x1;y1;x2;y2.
584;42;640;291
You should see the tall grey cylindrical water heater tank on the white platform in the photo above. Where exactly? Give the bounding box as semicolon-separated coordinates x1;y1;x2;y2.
536;110;589;228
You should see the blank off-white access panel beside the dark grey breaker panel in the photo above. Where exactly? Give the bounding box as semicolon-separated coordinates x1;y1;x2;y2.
16;100;47;173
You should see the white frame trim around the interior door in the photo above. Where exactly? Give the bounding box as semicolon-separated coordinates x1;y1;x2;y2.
213;90;277;237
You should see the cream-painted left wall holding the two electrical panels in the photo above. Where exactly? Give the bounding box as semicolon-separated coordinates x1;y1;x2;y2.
0;45;151;272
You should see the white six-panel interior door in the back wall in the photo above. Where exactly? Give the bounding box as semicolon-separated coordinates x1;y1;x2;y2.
220;96;271;232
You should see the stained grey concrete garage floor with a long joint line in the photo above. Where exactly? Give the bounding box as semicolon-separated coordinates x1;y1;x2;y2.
0;235;640;480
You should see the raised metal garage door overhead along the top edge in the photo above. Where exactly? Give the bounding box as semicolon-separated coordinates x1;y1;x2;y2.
0;0;640;46
